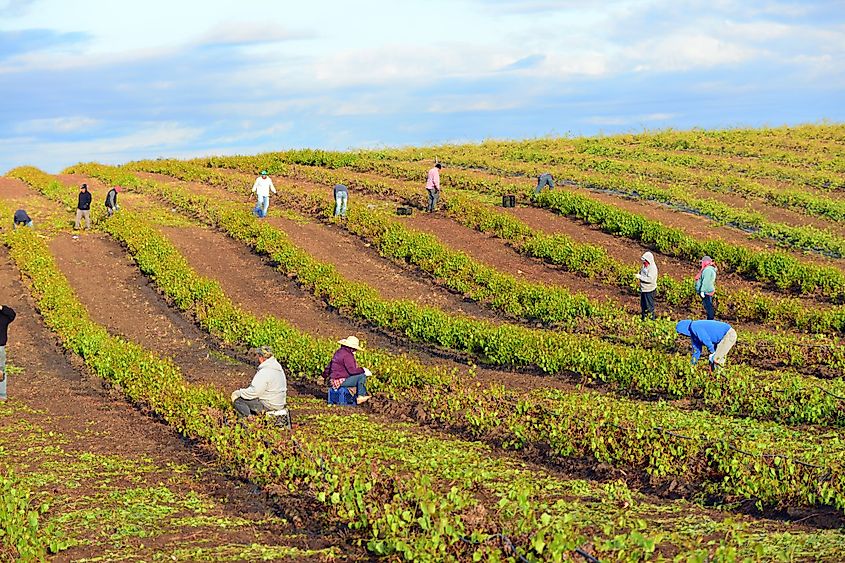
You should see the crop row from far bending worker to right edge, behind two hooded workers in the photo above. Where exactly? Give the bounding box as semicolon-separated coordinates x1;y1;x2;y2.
254;151;845;303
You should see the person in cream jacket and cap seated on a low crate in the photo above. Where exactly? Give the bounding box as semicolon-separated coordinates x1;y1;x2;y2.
232;346;288;416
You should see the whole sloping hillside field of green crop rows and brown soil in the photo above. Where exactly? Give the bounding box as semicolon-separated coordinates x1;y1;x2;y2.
0;123;845;563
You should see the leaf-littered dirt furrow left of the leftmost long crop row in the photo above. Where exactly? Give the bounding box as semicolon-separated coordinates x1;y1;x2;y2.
0;248;346;561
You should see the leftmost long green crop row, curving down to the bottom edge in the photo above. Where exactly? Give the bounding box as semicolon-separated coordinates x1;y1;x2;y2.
0;192;636;560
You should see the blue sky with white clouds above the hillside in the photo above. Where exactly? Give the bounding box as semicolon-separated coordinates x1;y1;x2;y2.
0;0;845;173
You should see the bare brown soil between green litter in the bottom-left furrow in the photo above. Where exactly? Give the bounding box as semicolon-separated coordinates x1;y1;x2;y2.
0;248;352;561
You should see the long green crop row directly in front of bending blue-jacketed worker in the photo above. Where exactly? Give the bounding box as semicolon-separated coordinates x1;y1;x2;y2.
57;166;845;432
